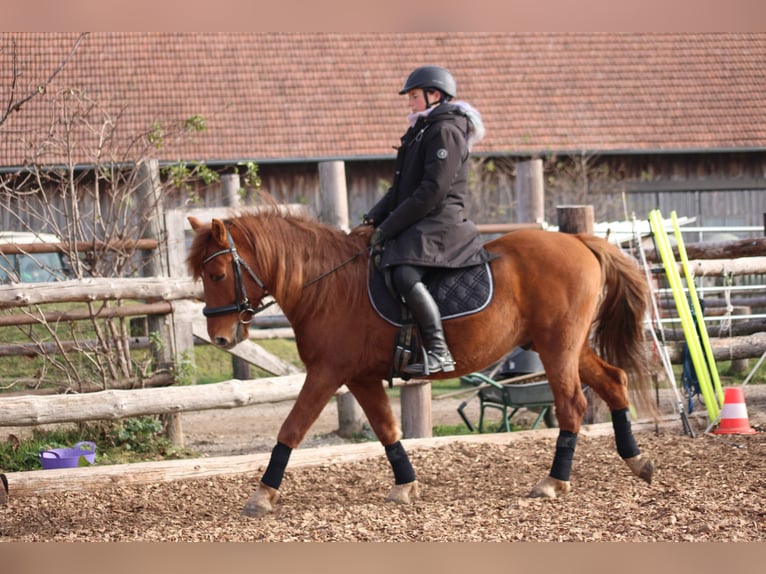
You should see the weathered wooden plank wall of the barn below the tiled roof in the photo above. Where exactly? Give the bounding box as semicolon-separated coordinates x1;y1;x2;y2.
0;153;766;240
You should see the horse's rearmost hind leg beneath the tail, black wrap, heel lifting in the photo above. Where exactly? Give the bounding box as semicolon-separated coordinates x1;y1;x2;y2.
580;348;655;483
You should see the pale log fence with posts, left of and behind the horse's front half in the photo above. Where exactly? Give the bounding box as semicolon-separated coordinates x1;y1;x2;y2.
0;162;474;445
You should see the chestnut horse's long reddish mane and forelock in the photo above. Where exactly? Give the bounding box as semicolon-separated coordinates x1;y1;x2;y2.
188;204;371;320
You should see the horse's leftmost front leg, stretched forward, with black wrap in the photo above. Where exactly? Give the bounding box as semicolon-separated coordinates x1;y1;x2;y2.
242;374;338;517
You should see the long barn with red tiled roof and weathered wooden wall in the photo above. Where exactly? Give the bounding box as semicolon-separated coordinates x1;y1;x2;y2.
0;32;766;236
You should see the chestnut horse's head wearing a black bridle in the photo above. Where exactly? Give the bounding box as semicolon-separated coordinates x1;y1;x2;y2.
187;217;268;349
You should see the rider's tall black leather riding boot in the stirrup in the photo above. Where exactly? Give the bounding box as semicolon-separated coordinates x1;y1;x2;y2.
402;283;455;376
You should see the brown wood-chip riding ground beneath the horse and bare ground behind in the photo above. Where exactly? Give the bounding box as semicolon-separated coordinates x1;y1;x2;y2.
0;387;766;542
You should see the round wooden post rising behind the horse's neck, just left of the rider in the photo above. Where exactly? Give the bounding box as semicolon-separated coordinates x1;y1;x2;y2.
317;161;365;438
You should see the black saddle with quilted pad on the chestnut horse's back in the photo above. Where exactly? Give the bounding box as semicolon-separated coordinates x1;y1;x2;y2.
367;261;494;385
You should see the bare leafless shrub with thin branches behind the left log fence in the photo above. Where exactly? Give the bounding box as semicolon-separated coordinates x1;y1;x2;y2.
0;34;231;392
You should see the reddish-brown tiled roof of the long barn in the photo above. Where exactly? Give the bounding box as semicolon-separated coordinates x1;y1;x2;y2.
0;33;766;169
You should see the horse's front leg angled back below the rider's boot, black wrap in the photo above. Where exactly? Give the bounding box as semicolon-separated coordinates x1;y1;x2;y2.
348;381;418;504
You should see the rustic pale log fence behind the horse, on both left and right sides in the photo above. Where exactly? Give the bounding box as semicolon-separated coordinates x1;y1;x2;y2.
0;161;766;450
